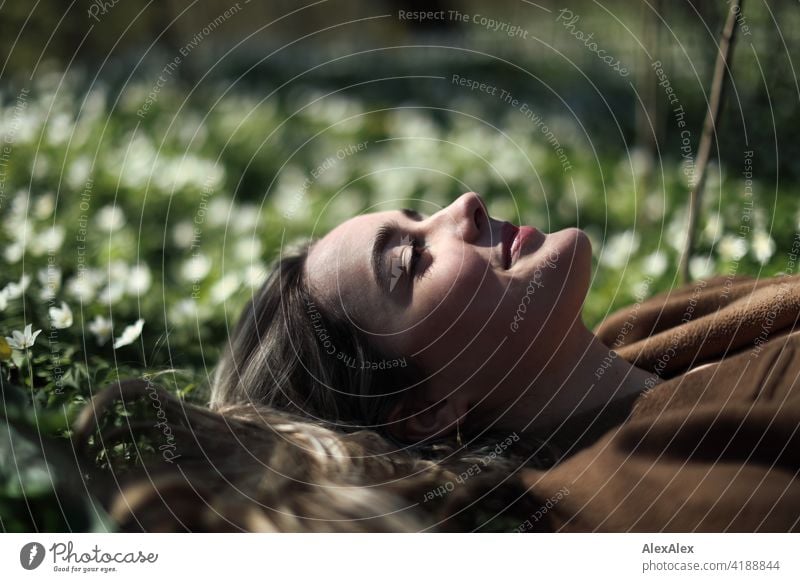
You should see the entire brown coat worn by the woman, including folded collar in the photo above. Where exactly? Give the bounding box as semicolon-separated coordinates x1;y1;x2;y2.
520;275;800;532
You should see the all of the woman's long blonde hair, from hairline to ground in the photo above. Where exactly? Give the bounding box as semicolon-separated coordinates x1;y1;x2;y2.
74;243;559;531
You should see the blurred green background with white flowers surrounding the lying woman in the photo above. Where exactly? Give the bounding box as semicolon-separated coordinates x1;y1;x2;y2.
0;0;800;530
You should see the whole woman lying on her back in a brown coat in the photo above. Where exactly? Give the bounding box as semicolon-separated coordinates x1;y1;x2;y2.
76;193;800;531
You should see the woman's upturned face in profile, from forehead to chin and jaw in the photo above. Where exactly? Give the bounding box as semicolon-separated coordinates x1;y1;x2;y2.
306;192;591;404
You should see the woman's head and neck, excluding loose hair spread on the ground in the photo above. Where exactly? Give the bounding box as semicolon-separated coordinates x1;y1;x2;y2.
212;192;659;450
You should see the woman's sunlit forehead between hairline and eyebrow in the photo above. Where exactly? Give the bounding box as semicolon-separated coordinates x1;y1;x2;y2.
306;210;400;311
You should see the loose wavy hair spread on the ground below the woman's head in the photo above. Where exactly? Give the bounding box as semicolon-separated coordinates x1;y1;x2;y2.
73;380;560;532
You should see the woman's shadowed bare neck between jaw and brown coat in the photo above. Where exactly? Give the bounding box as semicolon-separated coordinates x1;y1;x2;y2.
497;318;661;438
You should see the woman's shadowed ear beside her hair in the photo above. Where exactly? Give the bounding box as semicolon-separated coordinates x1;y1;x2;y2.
388;395;466;442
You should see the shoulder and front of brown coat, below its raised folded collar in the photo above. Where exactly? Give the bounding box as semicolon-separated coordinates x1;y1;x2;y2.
521;332;800;532
